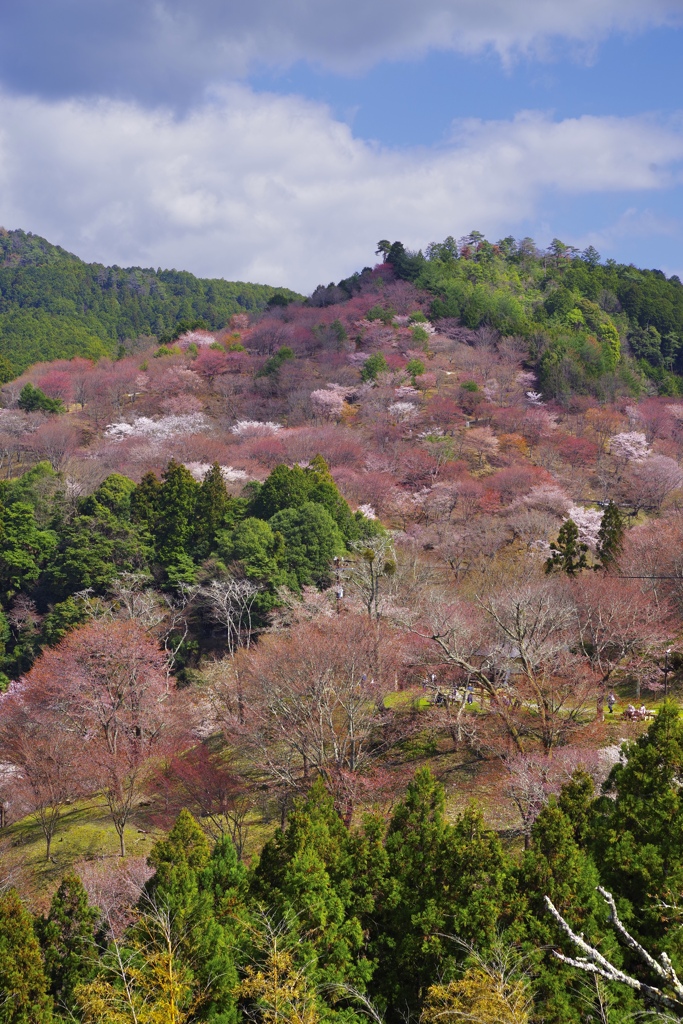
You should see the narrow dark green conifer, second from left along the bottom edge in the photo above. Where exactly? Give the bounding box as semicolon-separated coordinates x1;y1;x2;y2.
39;872;99;1010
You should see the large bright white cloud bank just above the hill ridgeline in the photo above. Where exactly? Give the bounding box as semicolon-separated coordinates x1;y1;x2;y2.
0;86;683;291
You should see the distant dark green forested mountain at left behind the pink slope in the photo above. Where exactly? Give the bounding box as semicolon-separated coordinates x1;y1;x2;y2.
0;228;301;379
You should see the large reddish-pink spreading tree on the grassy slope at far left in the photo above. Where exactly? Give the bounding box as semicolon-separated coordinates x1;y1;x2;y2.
22;620;171;856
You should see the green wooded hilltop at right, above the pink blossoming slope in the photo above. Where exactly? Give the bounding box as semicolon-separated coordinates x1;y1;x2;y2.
342;231;683;398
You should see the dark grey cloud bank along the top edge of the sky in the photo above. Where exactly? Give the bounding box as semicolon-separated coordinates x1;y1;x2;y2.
1;0;681;100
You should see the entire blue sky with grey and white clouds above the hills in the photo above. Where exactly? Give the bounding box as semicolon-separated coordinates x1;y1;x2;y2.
0;0;683;292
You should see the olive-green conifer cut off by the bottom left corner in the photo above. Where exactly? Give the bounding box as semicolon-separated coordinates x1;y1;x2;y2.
0;889;52;1024
